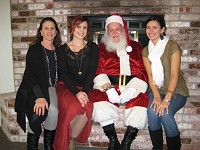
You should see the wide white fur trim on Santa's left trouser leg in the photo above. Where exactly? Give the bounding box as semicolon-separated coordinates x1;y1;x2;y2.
92;101;119;124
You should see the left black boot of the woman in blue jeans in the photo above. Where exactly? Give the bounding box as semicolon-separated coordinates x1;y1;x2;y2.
149;128;163;150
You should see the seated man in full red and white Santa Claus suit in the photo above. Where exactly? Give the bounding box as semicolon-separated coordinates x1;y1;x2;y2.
93;15;148;150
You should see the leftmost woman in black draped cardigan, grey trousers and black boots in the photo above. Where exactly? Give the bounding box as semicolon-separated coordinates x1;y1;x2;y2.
15;17;61;150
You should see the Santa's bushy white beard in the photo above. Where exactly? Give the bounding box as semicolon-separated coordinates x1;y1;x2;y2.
101;32;126;52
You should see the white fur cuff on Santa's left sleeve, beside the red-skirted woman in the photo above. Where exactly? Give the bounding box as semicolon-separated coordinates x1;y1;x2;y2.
93;74;111;91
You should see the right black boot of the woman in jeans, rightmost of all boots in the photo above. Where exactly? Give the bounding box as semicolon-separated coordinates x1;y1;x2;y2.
166;133;181;150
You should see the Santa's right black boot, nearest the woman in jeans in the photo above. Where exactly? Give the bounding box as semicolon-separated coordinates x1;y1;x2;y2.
121;126;138;150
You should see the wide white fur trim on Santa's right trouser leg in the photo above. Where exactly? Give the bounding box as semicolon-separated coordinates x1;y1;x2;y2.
124;106;147;129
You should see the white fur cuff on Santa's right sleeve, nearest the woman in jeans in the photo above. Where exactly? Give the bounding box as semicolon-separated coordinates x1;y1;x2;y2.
126;77;148;93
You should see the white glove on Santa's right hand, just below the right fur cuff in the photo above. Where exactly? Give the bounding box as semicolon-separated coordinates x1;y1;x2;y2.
119;88;140;104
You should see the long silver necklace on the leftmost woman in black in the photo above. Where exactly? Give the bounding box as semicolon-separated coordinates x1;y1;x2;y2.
44;47;58;87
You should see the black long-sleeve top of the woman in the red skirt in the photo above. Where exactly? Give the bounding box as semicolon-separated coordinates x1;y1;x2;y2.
57;41;99;94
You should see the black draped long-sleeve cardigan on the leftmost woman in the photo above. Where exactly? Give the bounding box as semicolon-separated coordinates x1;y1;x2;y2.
15;43;55;135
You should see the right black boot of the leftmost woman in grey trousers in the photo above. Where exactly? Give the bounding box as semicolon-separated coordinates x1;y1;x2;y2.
44;129;56;150
